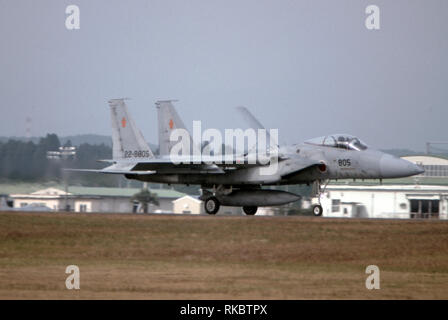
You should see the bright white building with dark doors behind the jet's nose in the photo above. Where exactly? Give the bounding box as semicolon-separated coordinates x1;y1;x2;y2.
321;155;448;219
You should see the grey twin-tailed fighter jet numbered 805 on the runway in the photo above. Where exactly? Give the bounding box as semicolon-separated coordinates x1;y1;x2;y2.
69;99;423;216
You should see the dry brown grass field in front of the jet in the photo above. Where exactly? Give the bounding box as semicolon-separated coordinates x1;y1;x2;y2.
0;212;448;299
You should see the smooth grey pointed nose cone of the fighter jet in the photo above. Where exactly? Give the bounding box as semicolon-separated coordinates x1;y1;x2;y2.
380;154;425;178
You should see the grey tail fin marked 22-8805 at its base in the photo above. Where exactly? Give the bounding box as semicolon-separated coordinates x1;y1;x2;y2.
109;99;154;159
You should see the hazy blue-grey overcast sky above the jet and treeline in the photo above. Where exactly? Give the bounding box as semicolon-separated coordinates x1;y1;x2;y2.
0;0;448;150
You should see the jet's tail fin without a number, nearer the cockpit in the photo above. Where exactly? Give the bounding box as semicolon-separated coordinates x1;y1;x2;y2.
156;100;193;156
